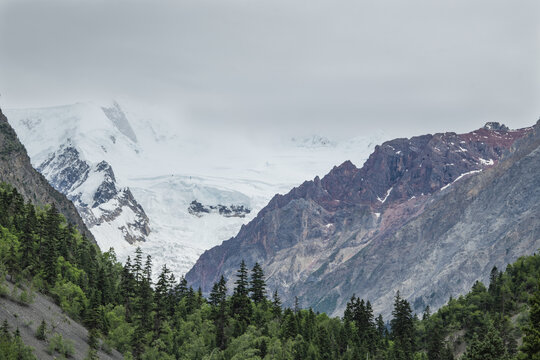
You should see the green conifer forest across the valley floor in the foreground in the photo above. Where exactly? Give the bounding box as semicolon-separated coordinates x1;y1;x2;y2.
0;184;540;360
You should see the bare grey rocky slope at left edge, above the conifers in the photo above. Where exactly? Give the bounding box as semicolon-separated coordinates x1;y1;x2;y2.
0;110;94;240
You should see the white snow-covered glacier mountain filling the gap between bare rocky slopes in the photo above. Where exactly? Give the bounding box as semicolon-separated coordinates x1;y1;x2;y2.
5;101;386;276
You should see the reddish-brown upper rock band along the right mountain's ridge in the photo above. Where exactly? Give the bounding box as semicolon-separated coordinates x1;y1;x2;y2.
261;124;532;213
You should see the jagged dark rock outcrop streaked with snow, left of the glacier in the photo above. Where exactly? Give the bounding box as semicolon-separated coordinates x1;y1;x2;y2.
38;140;150;244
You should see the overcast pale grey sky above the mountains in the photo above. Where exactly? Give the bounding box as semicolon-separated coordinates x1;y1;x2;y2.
0;0;540;139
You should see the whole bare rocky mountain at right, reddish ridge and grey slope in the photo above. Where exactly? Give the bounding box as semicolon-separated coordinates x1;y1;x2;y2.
186;124;540;315
